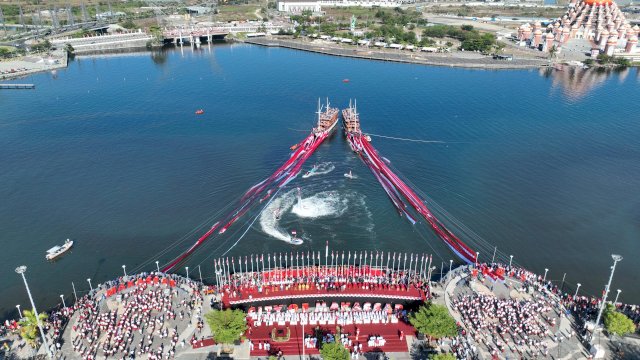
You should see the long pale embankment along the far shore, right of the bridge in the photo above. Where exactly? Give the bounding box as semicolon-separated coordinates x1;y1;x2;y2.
242;38;550;70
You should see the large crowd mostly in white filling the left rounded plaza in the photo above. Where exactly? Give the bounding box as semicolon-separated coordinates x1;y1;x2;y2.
71;275;203;360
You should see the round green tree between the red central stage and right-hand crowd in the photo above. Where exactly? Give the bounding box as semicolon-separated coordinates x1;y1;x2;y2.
409;303;458;339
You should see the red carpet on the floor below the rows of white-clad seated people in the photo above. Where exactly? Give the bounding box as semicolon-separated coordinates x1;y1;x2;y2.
247;321;415;356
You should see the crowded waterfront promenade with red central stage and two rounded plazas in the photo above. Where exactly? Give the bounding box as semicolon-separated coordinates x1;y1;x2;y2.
1;255;640;360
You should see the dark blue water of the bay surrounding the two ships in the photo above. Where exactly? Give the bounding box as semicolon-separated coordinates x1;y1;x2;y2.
0;45;640;318
